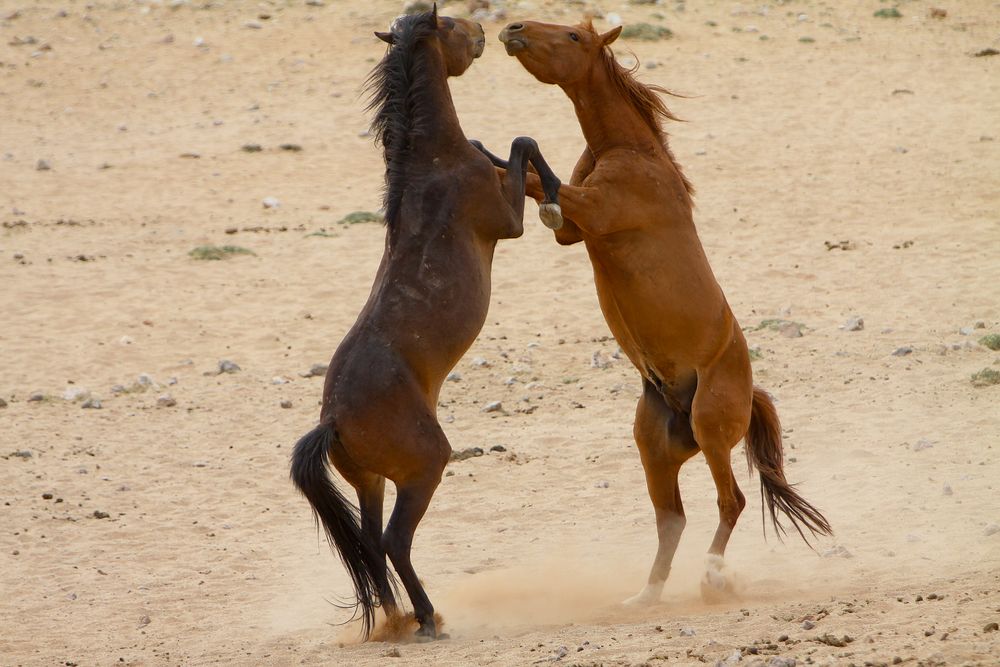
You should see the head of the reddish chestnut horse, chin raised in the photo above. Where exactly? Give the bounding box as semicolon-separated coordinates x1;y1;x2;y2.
500;21;622;85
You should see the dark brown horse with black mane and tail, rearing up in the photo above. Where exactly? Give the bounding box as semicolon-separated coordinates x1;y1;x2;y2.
291;8;559;638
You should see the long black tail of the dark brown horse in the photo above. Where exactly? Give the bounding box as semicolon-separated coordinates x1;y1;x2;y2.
292;424;397;639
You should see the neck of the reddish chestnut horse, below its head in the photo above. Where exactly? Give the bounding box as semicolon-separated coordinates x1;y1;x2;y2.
562;64;660;156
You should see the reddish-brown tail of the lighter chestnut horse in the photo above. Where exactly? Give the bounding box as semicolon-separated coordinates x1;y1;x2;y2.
746;387;833;546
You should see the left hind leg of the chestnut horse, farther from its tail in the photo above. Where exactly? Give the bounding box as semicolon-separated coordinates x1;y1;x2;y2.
624;382;698;605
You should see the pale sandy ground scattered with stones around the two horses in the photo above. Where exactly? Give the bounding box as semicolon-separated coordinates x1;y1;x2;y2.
0;0;1000;667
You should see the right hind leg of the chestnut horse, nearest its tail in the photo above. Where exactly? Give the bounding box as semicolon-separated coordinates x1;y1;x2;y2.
691;347;752;601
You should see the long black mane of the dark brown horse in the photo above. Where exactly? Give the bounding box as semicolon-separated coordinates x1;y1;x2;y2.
365;12;437;227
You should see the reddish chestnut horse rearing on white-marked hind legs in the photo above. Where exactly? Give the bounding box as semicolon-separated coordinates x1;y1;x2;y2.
500;21;831;603
